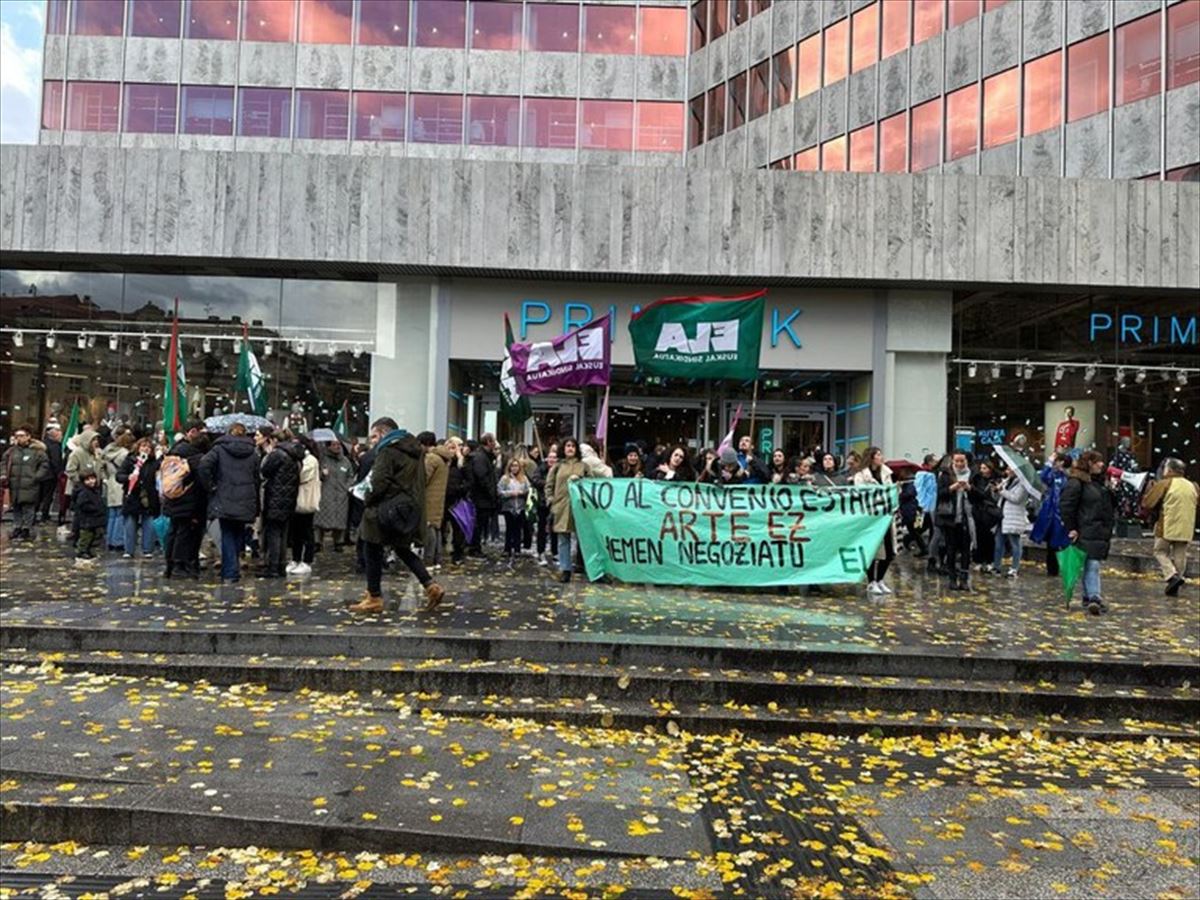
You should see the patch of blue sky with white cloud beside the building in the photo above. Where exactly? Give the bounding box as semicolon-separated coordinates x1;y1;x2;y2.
0;0;46;144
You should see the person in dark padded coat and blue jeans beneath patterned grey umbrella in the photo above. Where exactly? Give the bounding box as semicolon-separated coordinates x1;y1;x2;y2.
198;424;260;584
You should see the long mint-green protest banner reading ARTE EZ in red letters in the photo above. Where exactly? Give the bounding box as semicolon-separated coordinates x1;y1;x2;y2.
570;478;899;587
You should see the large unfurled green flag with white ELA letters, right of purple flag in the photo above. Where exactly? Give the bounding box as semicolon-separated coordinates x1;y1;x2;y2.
629;290;767;380
